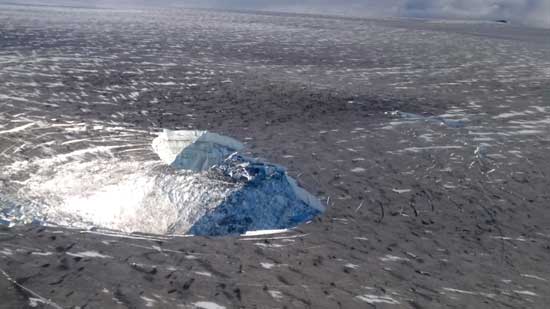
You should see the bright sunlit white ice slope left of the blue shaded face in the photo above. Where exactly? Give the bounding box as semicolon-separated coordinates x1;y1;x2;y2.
0;159;241;234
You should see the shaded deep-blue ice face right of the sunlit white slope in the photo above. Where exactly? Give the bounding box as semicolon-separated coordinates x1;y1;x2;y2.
190;155;324;235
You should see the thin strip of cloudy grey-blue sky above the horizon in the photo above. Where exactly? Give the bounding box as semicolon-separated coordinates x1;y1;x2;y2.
0;0;550;26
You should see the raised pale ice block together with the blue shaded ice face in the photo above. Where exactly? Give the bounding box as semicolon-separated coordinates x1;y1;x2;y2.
153;130;325;235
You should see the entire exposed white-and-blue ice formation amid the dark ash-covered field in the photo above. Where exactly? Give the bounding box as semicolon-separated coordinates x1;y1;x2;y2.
0;130;324;235
